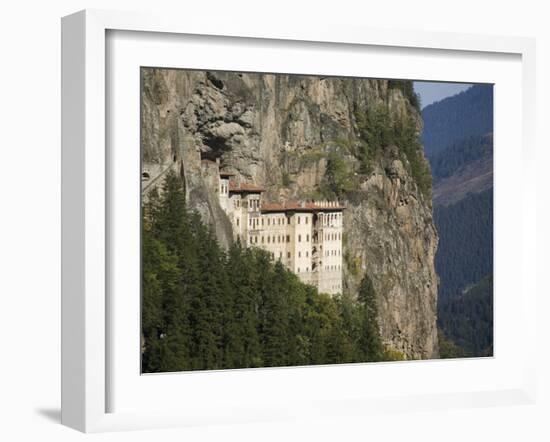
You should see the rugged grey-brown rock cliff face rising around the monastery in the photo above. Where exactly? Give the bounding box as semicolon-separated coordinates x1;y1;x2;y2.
141;69;438;359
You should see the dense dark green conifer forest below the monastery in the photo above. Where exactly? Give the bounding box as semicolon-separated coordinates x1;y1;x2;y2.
142;174;403;373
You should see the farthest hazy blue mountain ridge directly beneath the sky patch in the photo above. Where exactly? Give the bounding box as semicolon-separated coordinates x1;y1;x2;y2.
422;85;493;159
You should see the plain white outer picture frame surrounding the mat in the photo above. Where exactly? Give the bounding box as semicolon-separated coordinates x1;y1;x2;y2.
62;10;536;432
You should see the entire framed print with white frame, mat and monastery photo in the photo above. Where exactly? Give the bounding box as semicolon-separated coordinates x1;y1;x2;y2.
62;11;535;431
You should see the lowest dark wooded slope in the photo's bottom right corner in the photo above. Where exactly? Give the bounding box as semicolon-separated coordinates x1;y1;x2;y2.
438;275;493;357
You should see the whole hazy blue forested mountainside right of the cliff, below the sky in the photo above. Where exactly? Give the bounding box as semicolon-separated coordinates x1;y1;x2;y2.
422;85;493;357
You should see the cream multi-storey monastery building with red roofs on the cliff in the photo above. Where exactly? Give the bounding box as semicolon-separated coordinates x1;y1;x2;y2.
219;173;344;295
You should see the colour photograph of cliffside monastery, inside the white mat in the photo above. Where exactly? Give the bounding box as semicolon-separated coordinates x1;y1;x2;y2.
141;66;493;374
